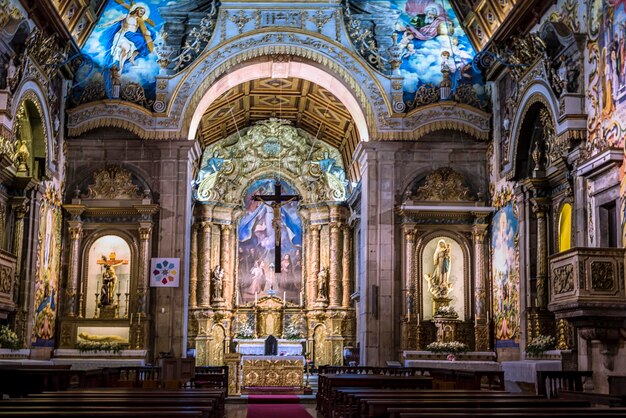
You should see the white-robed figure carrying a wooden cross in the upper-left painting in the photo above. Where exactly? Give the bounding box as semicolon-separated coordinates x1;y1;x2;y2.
100;0;156;73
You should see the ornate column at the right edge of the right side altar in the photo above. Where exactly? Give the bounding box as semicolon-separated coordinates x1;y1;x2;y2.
472;223;489;351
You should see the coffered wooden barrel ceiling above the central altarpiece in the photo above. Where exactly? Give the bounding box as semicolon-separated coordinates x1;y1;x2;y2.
200;78;359;178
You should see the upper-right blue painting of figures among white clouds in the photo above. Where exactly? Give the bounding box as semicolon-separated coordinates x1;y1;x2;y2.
389;0;484;102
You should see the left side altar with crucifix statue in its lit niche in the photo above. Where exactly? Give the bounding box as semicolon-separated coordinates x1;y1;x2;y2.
60;166;159;350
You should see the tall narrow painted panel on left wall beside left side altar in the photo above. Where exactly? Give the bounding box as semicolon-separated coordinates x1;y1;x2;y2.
31;188;62;347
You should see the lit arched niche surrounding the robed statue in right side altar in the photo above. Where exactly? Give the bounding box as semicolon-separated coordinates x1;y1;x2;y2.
417;231;471;321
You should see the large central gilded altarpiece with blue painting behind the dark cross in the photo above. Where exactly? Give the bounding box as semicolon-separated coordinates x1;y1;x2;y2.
188;119;355;365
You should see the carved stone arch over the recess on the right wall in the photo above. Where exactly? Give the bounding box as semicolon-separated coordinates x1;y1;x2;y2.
507;80;559;180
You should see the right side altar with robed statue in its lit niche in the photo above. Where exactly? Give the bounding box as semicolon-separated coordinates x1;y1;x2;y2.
398;167;493;351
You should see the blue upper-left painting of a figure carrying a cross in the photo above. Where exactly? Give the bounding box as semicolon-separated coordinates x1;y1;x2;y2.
74;0;172;104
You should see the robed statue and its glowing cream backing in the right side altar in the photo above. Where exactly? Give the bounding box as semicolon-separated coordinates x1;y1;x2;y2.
422;236;465;320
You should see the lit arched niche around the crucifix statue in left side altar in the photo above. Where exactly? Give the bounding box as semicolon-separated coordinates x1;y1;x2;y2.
81;228;137;318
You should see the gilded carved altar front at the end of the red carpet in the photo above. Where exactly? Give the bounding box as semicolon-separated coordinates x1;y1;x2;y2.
241;356;304;388
